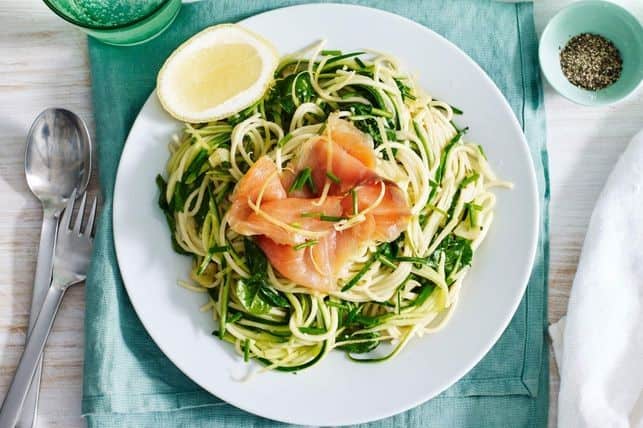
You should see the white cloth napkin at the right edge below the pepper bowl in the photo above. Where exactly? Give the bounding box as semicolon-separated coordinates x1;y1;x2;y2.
549;131;643;428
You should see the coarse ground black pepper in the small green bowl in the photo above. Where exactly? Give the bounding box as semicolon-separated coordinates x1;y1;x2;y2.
560;33;623;91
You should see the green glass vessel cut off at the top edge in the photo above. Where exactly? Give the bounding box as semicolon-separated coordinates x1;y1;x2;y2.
44;0;181;46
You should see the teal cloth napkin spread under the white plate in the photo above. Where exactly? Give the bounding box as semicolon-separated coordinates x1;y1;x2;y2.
82;0;549;428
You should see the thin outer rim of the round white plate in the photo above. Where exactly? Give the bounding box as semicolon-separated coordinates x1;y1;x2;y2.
111;3;541;425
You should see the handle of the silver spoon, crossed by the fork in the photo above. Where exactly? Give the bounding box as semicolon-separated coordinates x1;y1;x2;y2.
16;209;60;428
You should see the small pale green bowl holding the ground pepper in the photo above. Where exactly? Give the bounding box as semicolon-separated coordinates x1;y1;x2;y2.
538;0;643;106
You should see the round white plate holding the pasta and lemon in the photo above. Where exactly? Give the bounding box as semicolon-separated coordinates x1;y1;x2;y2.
113;4;538;425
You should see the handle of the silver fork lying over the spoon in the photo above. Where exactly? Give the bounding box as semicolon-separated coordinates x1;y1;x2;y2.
0;285;65;428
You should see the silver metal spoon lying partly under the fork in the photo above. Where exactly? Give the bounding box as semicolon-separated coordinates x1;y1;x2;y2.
17;108;92;428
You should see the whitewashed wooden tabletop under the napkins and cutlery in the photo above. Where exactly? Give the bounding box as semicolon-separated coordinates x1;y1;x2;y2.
0;0;643;428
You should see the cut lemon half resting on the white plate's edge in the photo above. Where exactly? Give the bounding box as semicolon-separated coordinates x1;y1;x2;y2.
157;24;279;123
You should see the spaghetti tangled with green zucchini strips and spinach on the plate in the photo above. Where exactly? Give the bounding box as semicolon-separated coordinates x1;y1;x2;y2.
157;42;511;371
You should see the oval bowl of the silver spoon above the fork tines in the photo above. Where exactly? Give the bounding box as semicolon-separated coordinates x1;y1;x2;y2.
25;108;92;211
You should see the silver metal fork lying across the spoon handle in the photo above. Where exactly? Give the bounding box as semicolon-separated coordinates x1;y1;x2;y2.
0;190;96;428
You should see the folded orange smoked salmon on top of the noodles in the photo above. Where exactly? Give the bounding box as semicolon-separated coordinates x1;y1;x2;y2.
228;116;411;292
